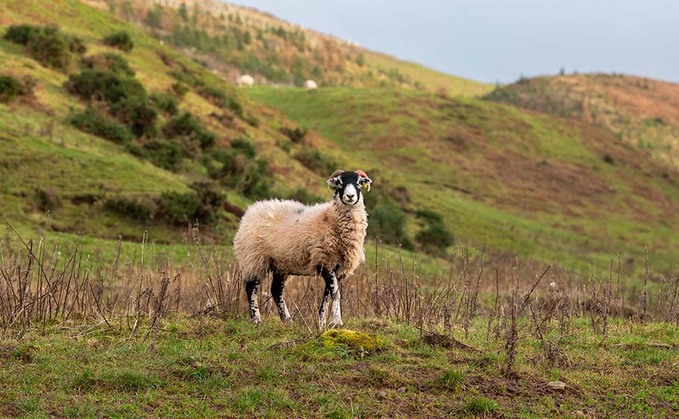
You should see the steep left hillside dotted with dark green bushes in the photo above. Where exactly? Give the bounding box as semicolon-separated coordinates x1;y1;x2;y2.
0;0;454;270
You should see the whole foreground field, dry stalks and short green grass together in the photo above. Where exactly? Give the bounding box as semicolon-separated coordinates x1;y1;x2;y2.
0;235;679;418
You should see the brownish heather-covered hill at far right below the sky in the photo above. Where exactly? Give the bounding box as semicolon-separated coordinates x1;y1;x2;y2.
487;74;679;166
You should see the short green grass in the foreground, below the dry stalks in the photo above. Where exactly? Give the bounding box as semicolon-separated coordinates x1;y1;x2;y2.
0;315;679;417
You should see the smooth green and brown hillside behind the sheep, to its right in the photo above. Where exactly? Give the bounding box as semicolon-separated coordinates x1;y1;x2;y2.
249;87;679;269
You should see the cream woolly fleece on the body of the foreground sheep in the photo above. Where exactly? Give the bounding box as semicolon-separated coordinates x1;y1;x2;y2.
234;194;368;281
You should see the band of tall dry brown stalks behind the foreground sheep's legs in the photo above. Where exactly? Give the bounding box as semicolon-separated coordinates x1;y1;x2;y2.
0;218;679;342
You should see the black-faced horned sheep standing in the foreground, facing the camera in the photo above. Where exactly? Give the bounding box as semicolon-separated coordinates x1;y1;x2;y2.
233;170;372;328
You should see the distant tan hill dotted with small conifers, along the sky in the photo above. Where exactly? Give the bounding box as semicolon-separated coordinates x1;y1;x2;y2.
87;0;491;96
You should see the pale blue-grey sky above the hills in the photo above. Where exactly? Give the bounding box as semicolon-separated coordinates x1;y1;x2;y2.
230;0;679;83
